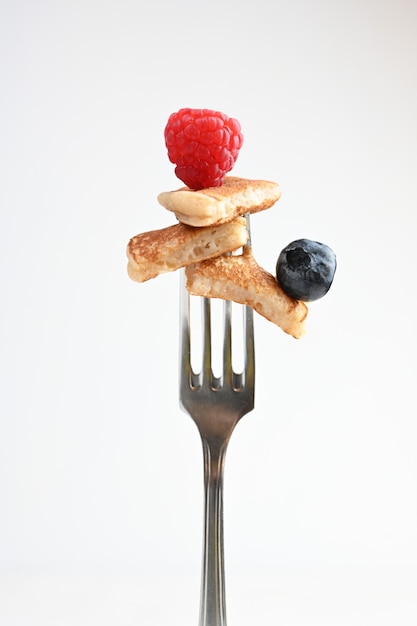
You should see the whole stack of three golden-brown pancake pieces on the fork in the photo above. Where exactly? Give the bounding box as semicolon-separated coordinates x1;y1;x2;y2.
127;176;308;338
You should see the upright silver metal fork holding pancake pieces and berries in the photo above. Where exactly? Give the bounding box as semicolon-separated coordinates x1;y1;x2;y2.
179;217;255;626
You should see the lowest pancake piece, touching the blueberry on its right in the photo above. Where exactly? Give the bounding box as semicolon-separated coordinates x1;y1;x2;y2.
185;247;308;339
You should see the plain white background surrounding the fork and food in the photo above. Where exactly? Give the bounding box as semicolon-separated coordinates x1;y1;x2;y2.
0;0;417;626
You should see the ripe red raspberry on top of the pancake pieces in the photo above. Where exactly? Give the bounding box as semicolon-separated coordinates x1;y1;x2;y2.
164;108;243;190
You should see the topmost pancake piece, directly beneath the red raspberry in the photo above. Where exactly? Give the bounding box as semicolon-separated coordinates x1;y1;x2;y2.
158;176;281;227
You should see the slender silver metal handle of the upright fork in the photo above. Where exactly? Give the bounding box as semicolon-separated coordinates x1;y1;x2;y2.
199;437;227;626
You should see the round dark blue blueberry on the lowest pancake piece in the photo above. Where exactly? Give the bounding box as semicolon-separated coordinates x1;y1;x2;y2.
276;239;336;302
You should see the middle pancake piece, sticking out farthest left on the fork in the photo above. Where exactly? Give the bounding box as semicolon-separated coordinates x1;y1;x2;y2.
126;217;249;283
